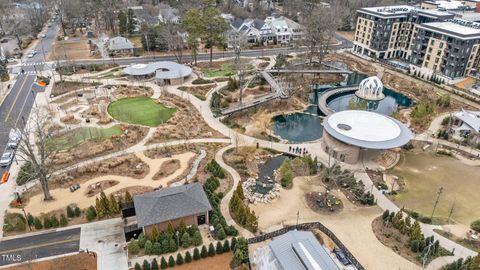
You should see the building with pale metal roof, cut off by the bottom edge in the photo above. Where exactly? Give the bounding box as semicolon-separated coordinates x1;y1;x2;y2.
255;231;340;270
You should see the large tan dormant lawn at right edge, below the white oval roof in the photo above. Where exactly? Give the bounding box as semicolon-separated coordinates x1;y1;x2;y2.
389;151;480;226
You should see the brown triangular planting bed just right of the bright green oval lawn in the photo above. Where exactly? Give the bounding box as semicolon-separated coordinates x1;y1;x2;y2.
148;92;224;144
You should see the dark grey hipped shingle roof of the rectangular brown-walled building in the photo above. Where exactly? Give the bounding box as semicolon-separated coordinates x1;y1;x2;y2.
133;183;212;228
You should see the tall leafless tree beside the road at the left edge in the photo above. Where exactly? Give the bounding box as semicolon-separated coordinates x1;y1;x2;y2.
17;108;56;201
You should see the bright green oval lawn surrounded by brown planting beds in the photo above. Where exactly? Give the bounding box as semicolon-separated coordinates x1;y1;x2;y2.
108;97;177;127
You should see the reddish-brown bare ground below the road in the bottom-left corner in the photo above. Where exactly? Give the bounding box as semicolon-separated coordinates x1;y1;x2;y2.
6;253;97;270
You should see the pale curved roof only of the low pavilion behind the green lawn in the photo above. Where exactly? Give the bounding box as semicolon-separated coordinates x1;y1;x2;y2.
123;61;192;79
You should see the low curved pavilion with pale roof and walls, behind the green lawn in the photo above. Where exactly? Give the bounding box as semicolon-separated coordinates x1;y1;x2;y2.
123;61;192;85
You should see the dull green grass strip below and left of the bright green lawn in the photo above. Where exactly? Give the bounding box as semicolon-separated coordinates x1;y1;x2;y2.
49;126;122;151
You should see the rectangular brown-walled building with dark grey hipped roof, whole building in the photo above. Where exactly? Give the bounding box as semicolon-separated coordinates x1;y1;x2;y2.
133;183;212;235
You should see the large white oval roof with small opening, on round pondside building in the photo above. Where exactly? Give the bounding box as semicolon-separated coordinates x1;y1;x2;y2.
323;110;412;149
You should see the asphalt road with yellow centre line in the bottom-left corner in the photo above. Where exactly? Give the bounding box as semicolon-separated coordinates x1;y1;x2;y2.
0;228;81;266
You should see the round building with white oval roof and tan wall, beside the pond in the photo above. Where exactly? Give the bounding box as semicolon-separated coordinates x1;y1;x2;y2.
321;110;412;164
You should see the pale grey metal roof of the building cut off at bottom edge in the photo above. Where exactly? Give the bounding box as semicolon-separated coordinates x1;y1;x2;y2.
269;231;340;270
